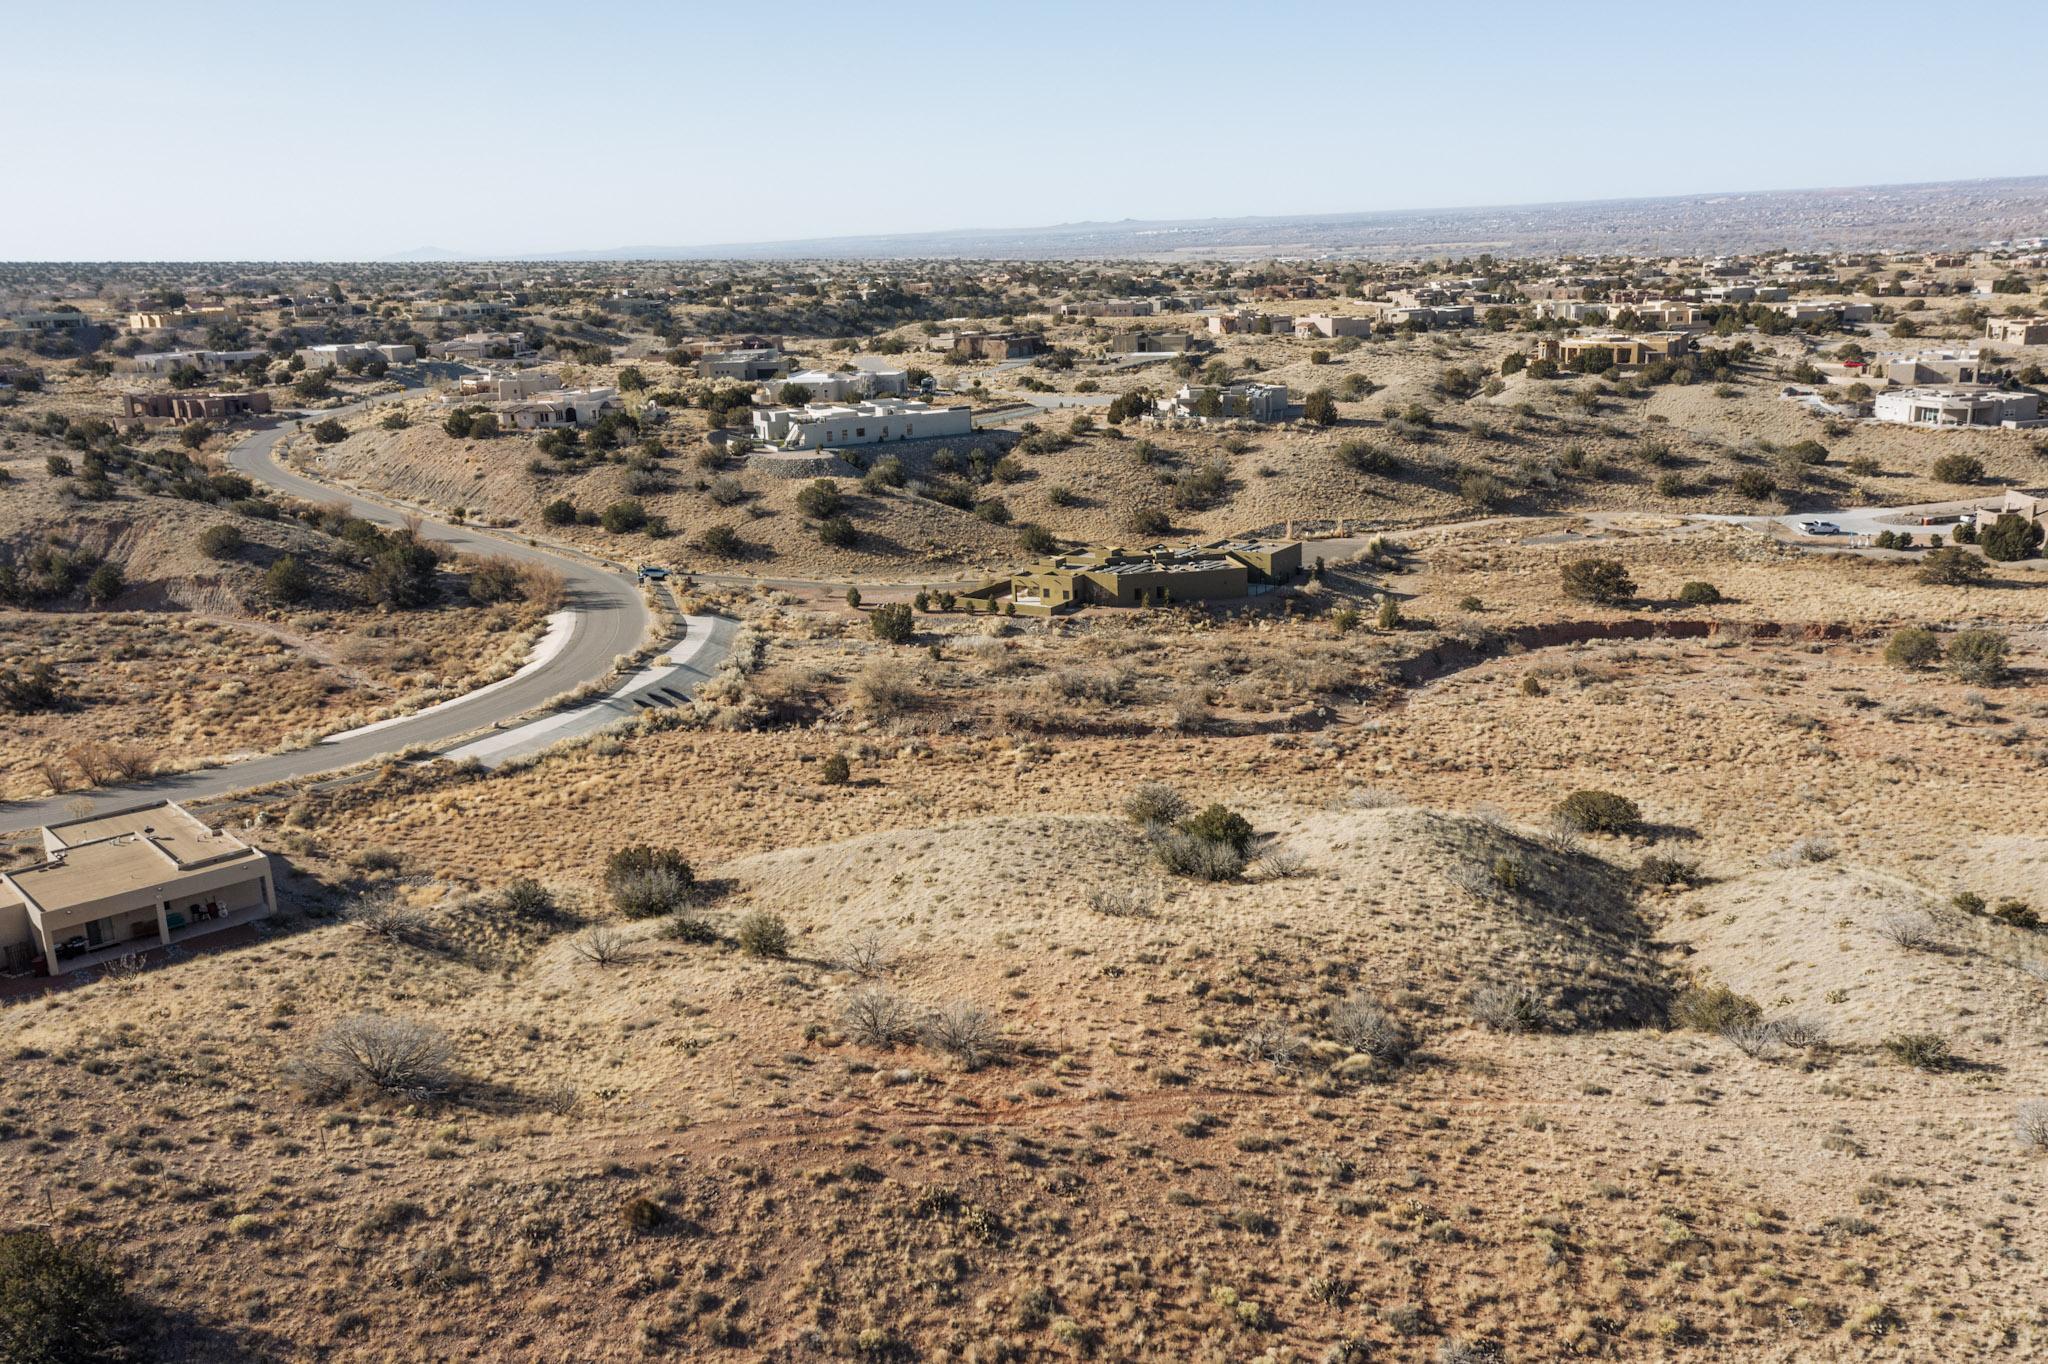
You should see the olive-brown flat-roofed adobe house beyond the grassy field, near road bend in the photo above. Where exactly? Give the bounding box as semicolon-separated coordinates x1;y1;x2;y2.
958;541;1300;616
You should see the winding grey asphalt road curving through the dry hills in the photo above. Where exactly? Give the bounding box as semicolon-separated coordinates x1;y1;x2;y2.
0;376;688;829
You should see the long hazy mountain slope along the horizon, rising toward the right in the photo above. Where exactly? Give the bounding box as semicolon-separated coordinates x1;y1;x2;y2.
393;176;2048;260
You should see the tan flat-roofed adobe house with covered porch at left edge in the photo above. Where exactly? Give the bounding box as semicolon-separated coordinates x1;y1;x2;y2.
0;801;276;975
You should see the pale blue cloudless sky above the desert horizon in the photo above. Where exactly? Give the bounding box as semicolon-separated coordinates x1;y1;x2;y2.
0;0;2048;260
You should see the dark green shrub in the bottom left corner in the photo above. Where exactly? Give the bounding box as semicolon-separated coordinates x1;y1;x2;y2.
0;1227;145;1364
